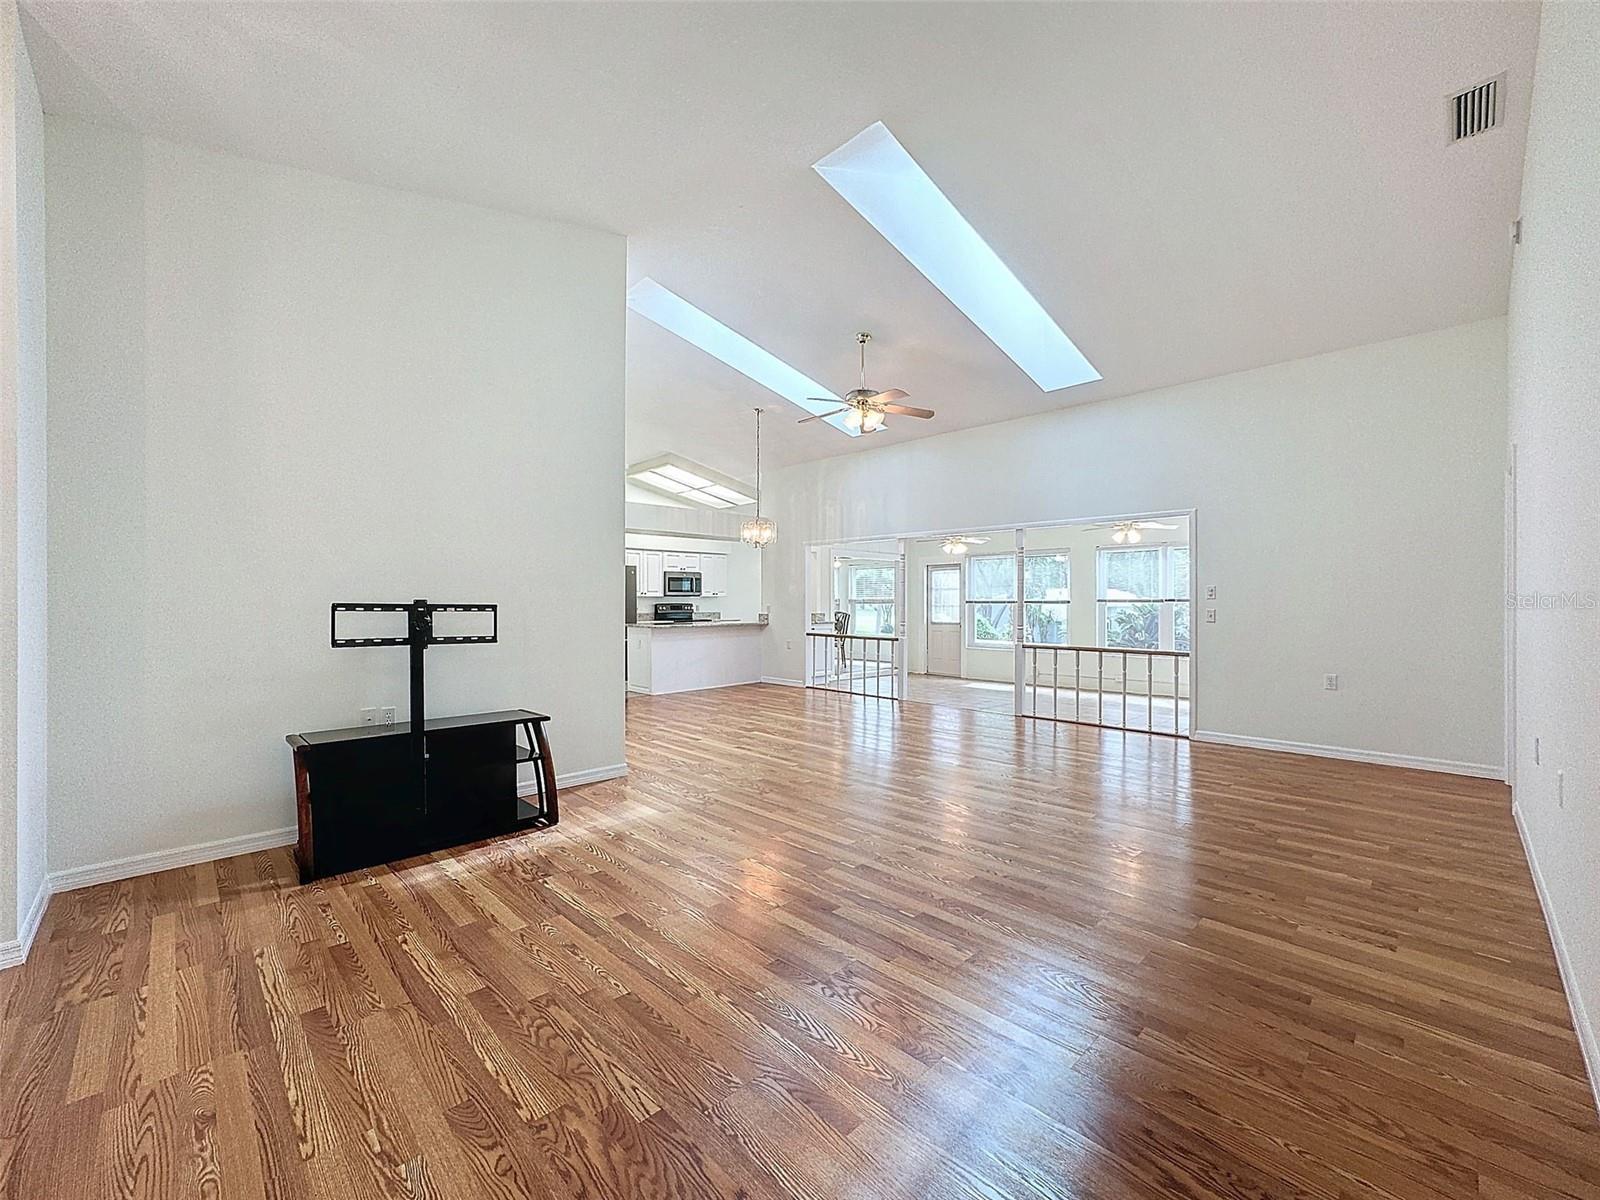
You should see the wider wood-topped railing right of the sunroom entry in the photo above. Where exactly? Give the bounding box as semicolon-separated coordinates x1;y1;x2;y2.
1019;642;1189;738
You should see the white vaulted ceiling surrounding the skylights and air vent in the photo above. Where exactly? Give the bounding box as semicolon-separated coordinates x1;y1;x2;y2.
26;0;1538;478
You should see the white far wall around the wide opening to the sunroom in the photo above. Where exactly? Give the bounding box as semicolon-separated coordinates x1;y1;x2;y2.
765;320;1506;773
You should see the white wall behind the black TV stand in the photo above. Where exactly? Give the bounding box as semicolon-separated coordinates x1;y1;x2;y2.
46;118;626;870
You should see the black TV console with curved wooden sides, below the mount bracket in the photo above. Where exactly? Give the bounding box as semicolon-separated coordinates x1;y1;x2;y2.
288;709;560;883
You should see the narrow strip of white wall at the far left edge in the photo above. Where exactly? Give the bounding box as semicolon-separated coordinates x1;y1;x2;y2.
0;3;46;960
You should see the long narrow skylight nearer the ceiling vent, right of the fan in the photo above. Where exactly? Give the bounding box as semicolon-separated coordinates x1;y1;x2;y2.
814;122;1101;392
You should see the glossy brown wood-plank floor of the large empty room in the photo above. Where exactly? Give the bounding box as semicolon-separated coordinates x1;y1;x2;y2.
0;686;1600;1200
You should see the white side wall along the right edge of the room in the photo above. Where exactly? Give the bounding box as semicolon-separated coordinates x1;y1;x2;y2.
1509;3;1600;1093
